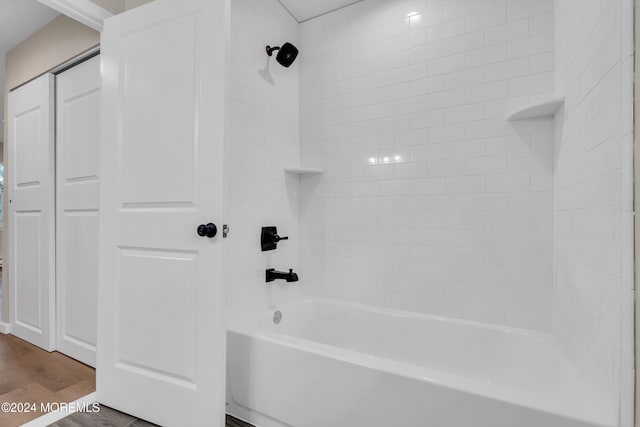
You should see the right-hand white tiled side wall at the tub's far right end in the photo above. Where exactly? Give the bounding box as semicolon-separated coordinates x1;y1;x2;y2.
553;0;634;426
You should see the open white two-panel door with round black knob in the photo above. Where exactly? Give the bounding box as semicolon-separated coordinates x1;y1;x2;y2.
97;0;228;427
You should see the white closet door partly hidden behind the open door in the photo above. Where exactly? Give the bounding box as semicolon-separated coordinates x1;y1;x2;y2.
56;56;101;366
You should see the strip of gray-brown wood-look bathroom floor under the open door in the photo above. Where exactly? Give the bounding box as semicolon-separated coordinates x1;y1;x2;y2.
49;405;253;427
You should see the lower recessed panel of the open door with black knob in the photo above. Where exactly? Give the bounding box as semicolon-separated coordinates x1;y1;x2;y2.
117;249;198;387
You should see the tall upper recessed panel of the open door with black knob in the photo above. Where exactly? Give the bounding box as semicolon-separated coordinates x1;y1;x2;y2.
120;15;198;208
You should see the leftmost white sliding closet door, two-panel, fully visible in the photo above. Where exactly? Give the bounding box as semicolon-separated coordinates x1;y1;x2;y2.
7;74;55;351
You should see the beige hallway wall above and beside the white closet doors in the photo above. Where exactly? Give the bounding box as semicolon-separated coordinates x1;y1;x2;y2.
2;15;99;322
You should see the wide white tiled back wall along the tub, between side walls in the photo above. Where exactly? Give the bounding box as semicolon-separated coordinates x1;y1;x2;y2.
300;0;554;330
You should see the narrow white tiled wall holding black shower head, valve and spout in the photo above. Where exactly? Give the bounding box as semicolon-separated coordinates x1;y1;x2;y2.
225;0;299;309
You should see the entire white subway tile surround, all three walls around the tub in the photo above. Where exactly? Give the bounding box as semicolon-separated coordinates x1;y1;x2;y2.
225;0;634;427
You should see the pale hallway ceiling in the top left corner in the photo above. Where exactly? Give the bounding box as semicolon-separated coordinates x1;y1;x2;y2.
0;0;58;141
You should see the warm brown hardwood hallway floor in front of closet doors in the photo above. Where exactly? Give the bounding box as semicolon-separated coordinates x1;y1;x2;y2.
0;334;96;427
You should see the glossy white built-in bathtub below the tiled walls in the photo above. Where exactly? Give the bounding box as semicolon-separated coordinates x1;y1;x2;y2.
227;299;617;427
